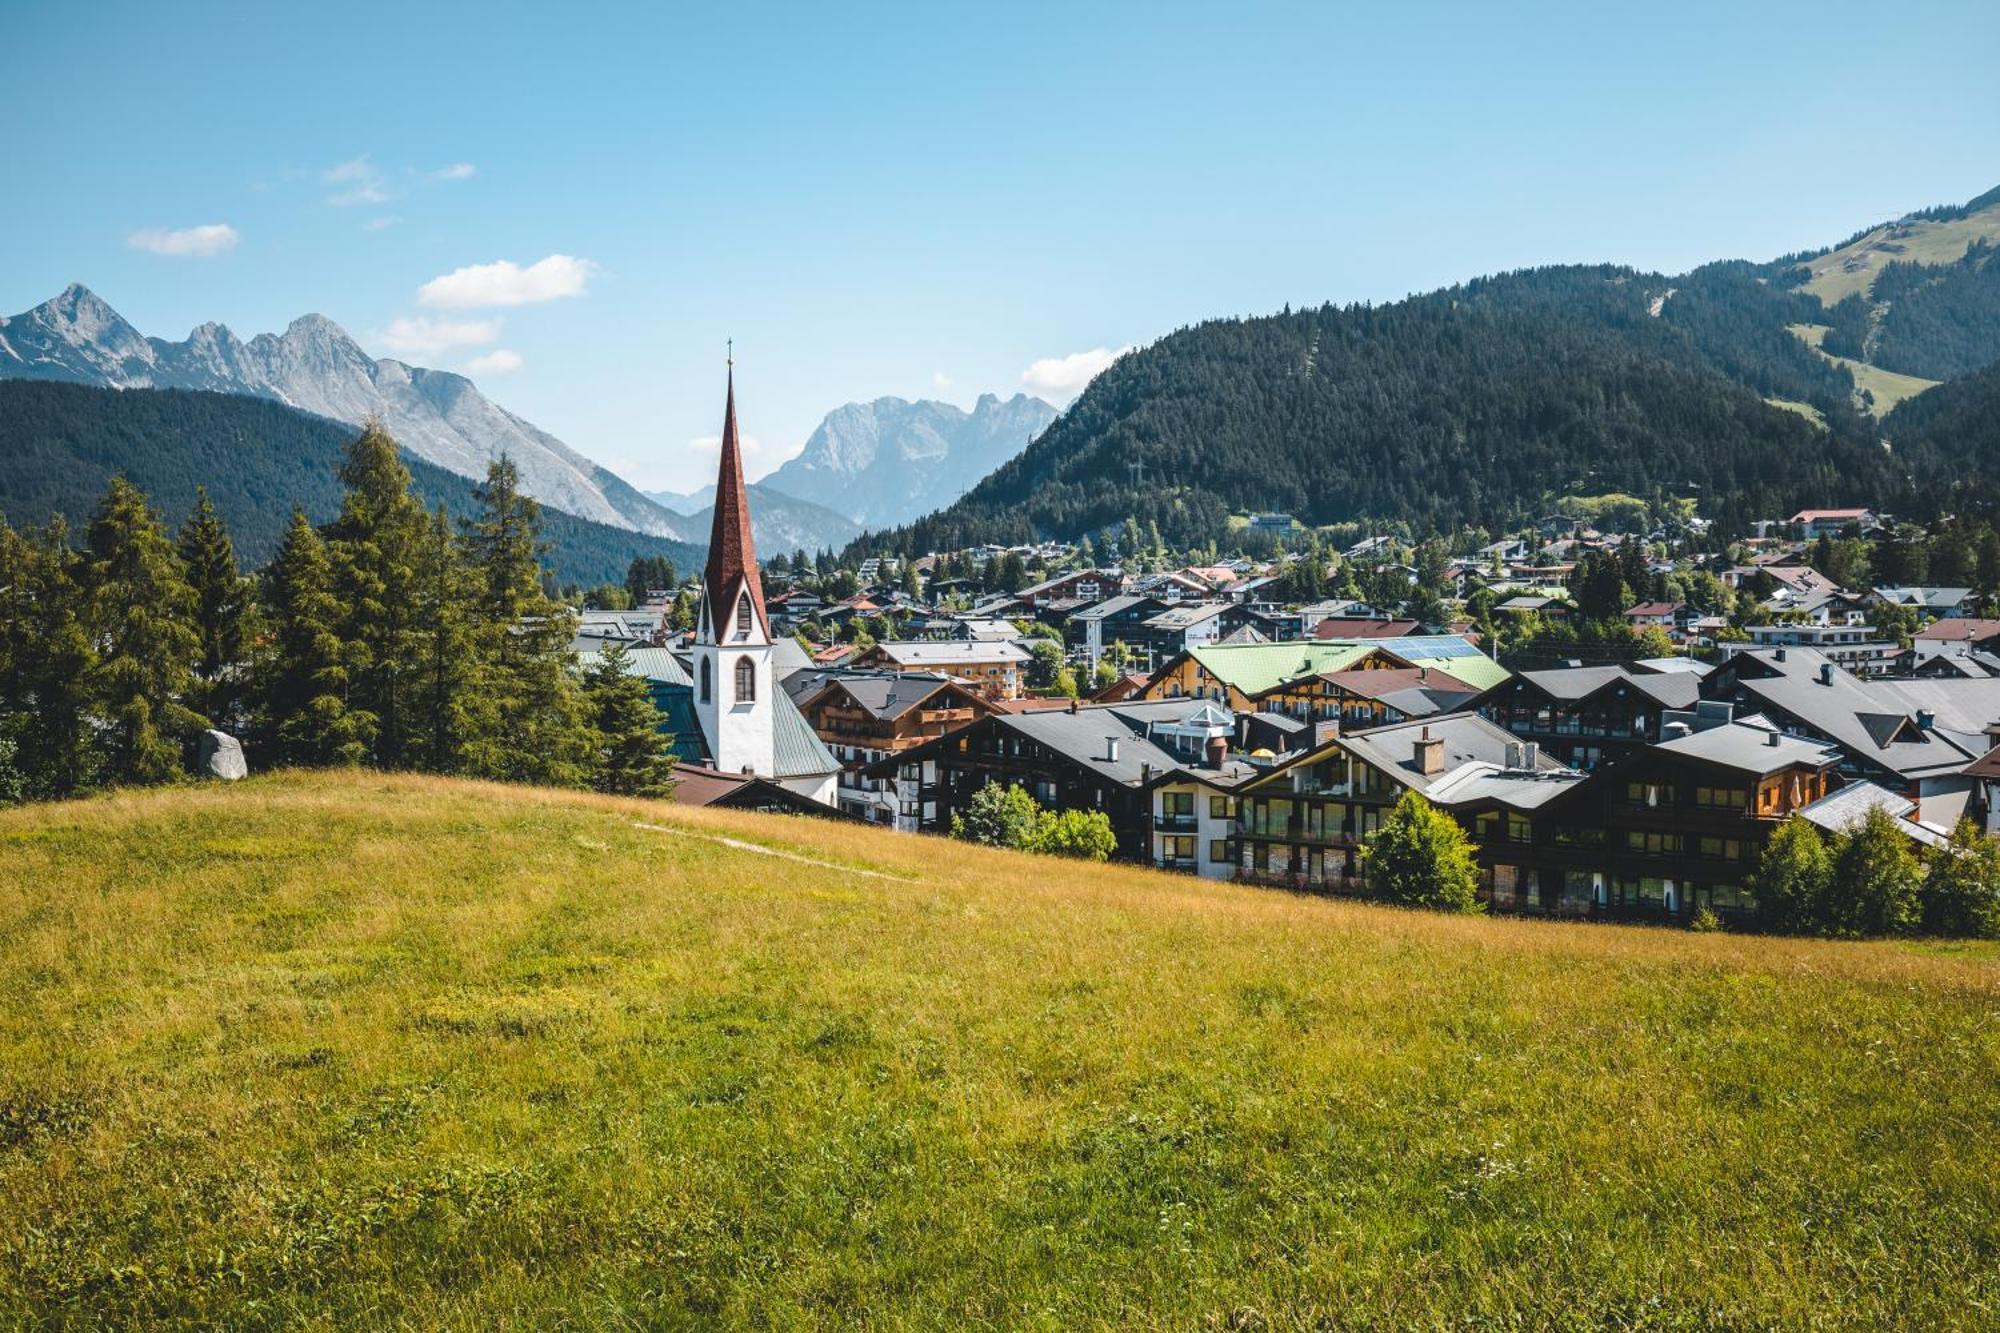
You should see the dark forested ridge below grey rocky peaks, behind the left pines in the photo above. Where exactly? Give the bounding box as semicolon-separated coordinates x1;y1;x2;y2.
0;380;704;586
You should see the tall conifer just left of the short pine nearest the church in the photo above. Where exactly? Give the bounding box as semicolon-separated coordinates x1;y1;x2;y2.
466;458;596;787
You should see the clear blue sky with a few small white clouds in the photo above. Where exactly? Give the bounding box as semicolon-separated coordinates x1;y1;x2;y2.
0;0;2000;488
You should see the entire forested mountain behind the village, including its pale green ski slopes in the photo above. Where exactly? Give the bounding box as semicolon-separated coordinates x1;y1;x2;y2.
848;190;2000;554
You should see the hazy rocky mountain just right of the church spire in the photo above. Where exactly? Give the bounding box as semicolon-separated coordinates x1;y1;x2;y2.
762;394;1058;528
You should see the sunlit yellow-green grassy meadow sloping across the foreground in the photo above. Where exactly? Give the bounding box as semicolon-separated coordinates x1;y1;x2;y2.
0;775;2000;1329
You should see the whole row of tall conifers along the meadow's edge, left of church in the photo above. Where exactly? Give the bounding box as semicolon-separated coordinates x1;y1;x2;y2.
0;426;672;801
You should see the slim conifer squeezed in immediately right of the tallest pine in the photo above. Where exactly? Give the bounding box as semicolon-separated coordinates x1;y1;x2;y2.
410;504;478;773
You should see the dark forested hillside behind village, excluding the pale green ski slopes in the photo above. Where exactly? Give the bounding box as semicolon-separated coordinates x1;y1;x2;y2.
870;266;1908;550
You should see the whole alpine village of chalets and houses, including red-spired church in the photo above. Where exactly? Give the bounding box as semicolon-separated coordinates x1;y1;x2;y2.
576;376;2000;925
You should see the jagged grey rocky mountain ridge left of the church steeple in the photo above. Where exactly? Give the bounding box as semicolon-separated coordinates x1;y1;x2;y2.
0;284;700;540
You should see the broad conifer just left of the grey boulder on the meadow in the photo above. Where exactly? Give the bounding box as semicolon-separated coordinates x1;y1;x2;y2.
88;476;206;783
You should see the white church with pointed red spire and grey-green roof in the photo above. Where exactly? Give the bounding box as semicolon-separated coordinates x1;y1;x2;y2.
596;364;840;813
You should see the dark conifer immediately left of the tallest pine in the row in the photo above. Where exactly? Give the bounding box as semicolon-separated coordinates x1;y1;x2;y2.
256;508;376;765
